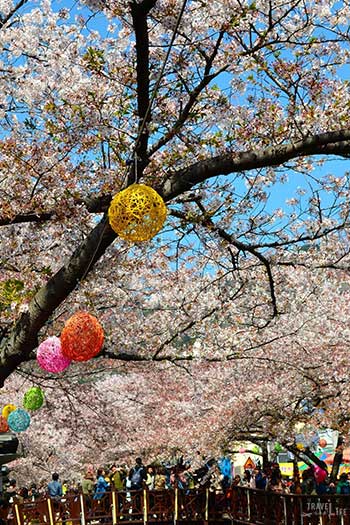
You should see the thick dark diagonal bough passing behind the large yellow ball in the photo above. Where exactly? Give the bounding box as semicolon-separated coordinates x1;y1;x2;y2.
0;130;350;384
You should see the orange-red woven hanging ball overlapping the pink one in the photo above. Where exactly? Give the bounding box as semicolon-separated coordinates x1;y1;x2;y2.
61;312;104;361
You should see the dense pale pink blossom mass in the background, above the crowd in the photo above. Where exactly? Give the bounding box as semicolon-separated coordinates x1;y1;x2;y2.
5;262;349;477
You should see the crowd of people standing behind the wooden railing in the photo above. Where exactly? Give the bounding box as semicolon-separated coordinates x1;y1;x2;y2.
3;457;350;503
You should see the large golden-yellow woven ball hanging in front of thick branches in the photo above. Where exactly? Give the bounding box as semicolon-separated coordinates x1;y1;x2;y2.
108;184;167;242
